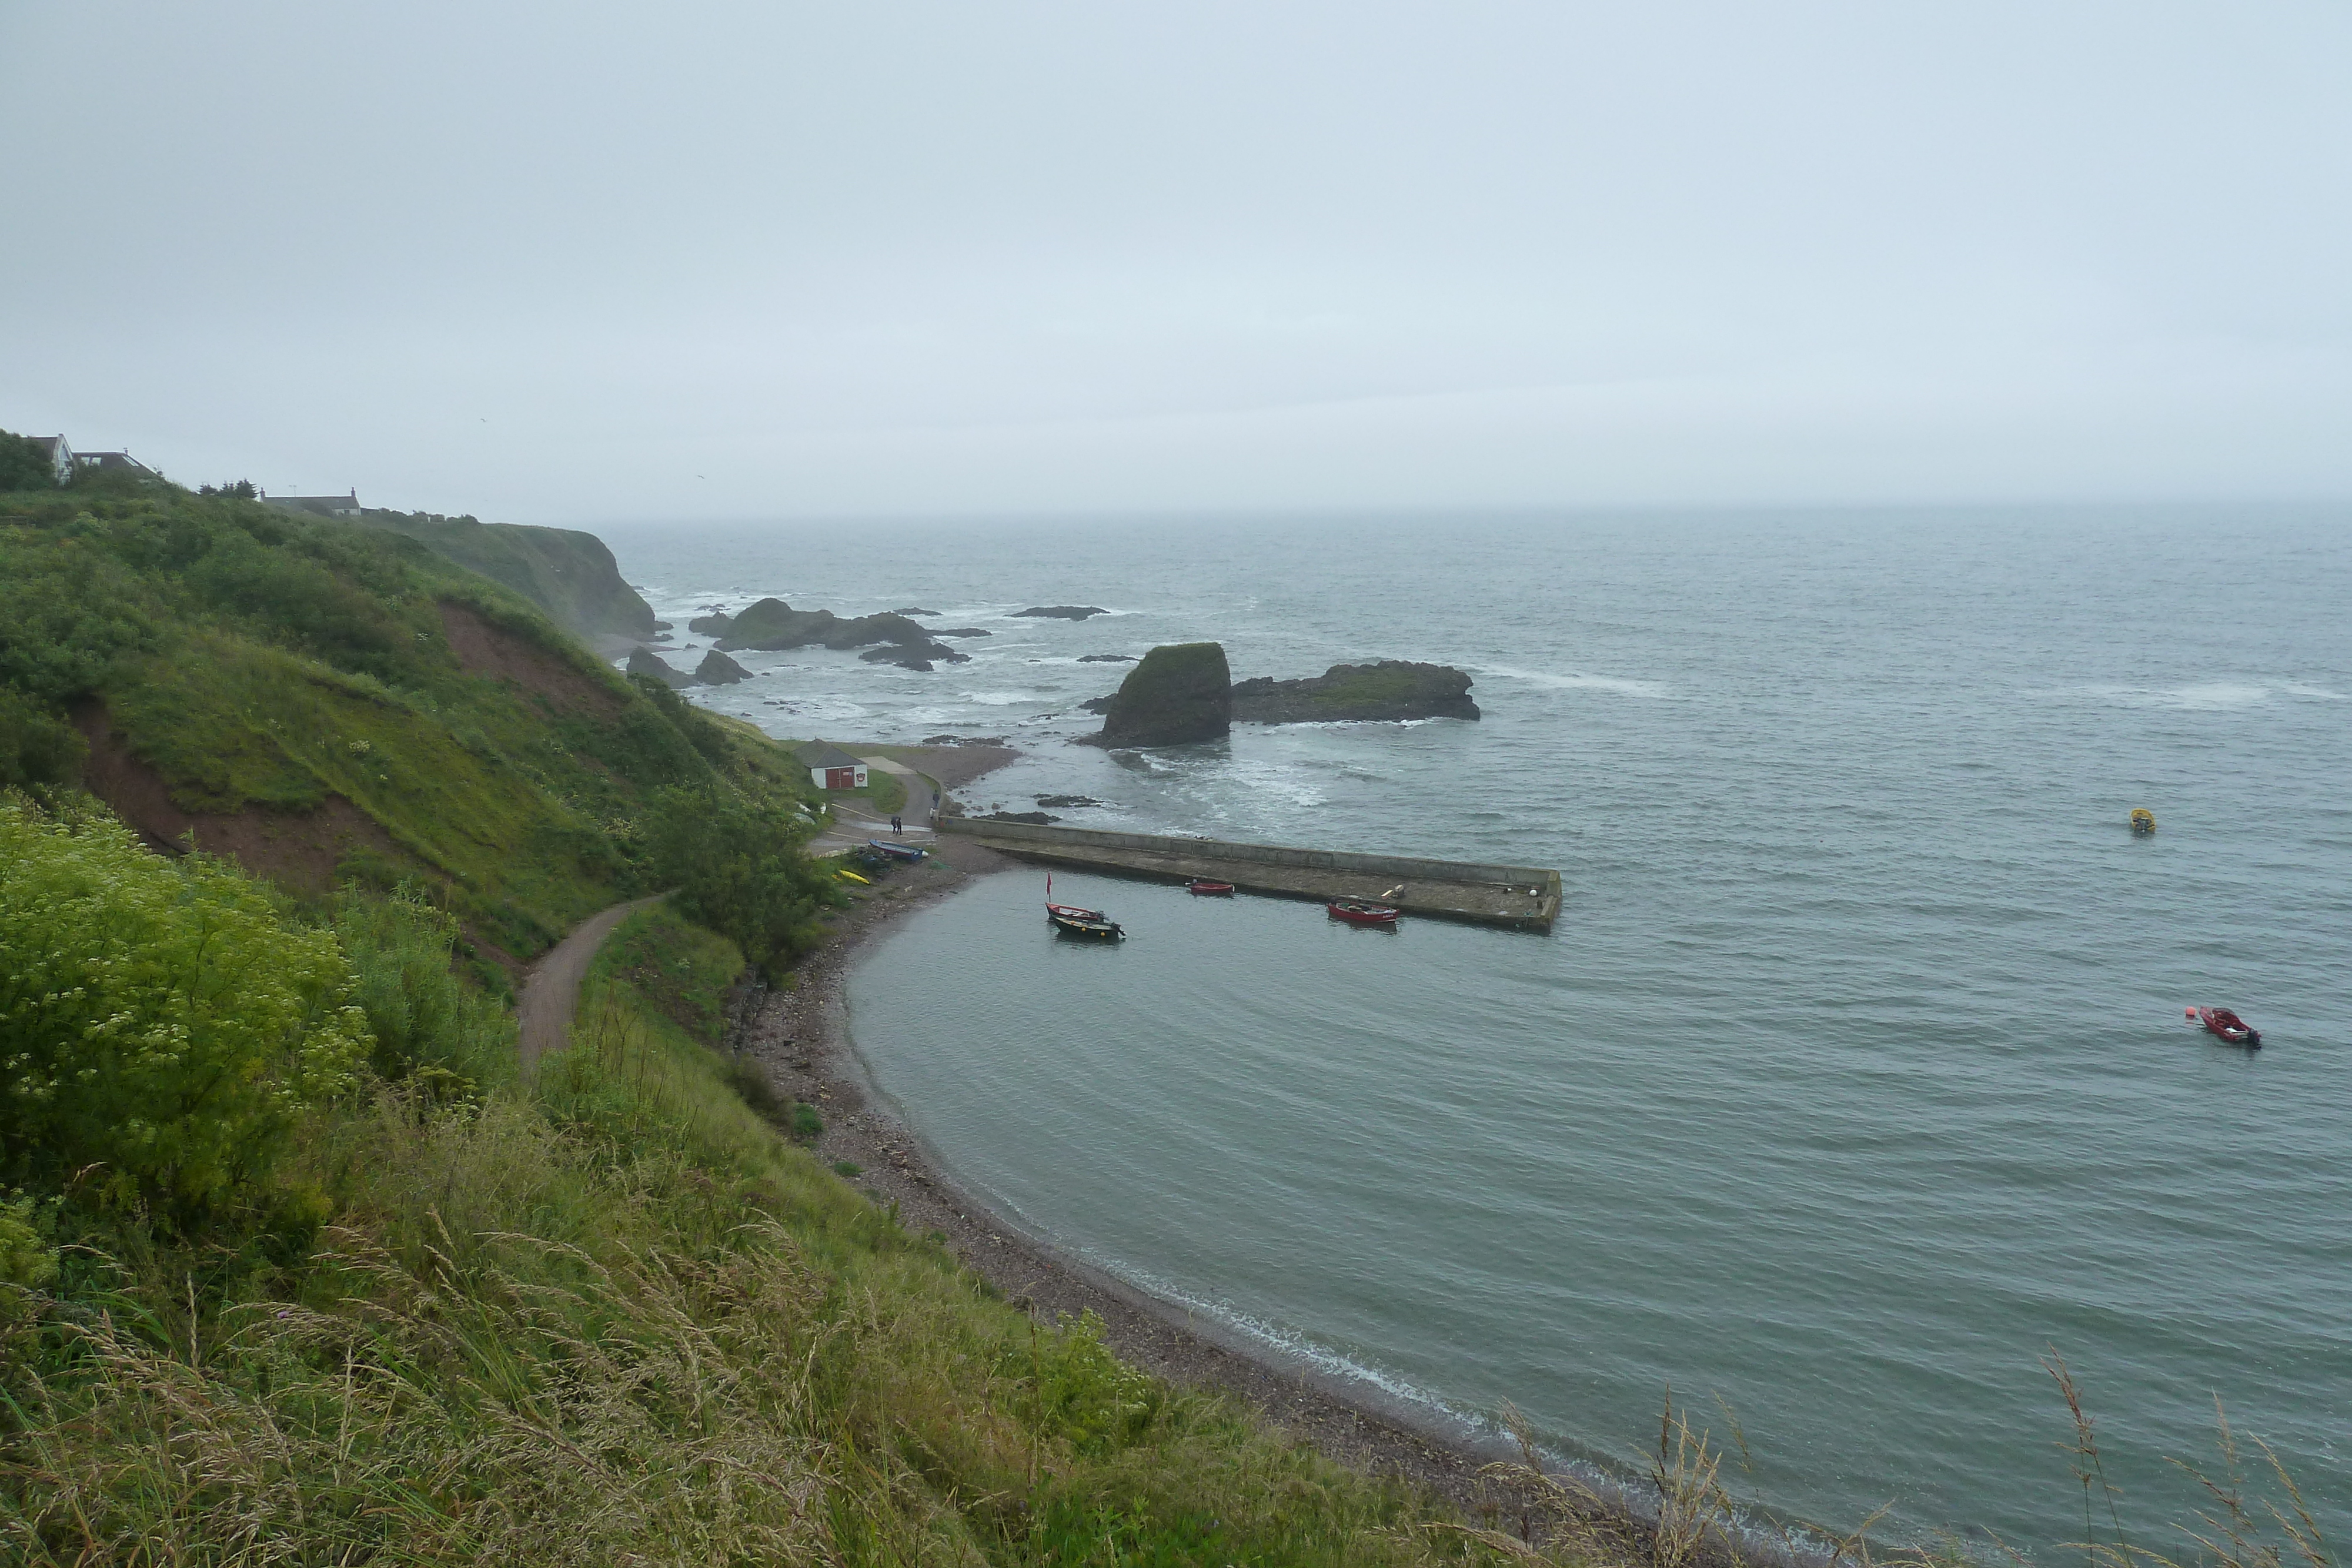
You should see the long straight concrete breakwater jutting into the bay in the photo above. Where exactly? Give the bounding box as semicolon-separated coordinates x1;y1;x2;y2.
936;815;1559;931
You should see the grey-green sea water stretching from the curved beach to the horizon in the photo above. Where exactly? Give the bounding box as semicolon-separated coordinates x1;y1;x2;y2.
604;508;2352;1549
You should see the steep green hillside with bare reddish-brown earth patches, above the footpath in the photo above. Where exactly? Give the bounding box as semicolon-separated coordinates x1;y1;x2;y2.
0;460;807;957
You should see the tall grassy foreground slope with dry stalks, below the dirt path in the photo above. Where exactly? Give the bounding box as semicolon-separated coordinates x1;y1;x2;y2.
0;799;1491;1566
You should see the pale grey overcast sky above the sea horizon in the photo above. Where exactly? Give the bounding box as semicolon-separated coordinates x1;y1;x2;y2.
0;0;2352;524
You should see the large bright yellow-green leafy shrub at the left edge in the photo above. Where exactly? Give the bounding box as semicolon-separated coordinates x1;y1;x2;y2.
0;797;367;1213
